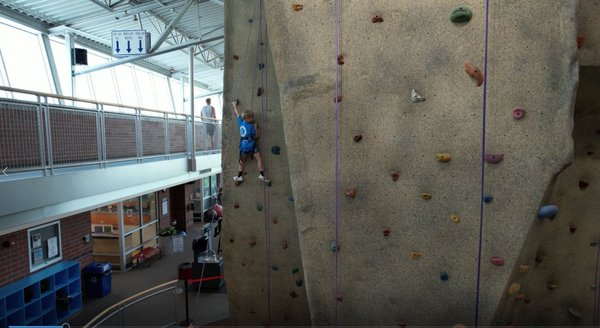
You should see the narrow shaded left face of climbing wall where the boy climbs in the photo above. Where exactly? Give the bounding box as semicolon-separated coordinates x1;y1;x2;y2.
223;1;310;326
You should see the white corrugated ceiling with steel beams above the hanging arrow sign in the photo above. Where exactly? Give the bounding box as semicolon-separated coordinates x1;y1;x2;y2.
0;0;224;93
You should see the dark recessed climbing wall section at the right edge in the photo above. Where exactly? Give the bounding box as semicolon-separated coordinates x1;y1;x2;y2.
496;66;600;326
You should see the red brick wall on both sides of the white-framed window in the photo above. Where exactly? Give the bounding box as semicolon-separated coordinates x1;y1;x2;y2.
0;212;92;287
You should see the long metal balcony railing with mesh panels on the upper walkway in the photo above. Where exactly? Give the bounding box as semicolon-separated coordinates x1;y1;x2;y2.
0;86;221;175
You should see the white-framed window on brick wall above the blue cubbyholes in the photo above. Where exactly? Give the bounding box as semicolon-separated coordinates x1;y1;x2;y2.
27;221;62;272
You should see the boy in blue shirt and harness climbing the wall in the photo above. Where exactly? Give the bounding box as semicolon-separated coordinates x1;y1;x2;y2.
232;100;270;184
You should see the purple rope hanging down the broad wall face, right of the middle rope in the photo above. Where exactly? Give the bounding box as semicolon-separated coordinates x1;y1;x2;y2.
475;0;490;327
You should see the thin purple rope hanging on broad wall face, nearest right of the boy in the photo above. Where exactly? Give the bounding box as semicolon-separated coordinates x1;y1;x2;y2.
334;0;340;327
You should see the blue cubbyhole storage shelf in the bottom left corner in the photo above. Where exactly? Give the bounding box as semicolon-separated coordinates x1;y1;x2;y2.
0;261;82;328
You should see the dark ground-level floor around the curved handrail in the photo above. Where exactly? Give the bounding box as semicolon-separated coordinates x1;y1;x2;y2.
68;222;229;327
